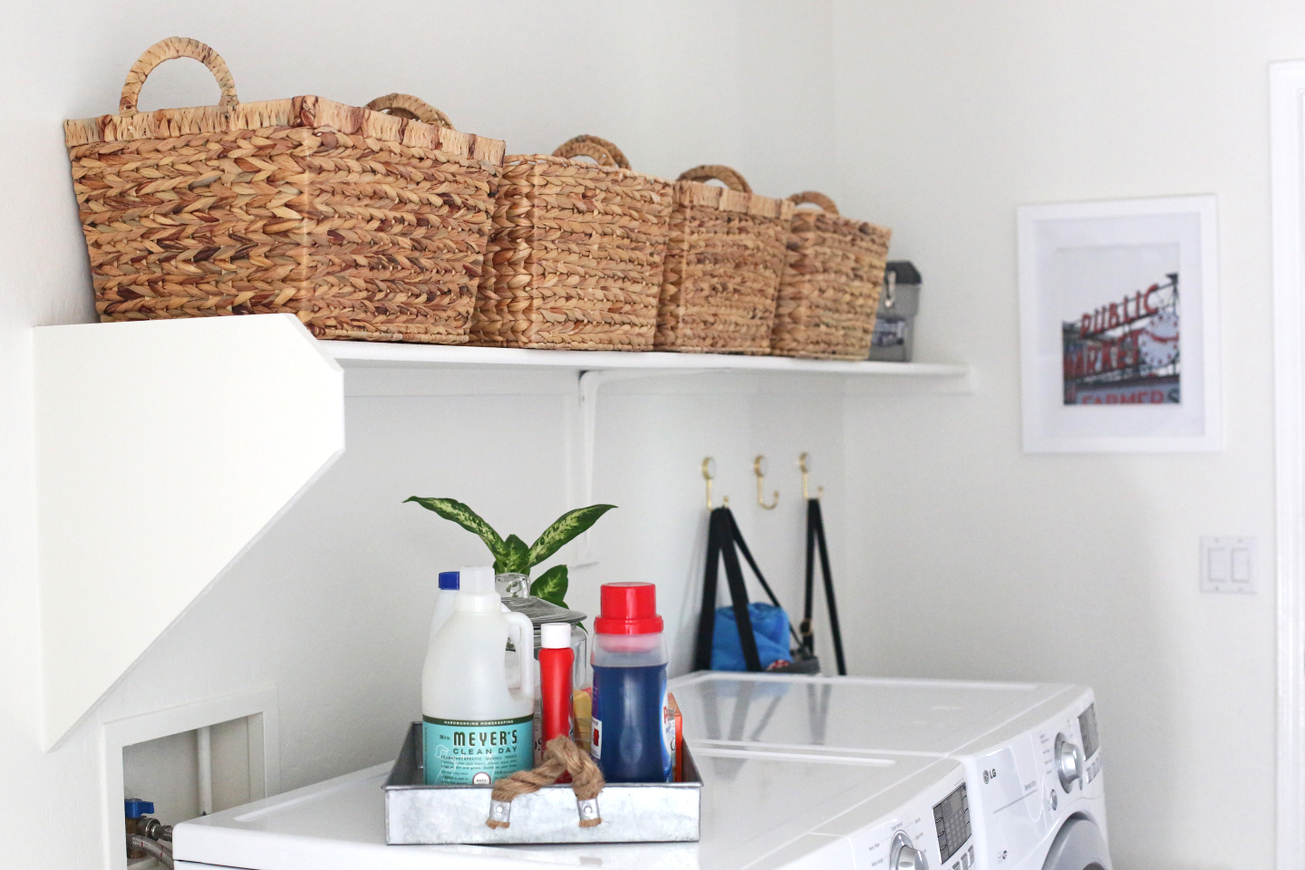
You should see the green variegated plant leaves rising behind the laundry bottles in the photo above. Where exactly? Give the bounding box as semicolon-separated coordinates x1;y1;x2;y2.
405;496;616;607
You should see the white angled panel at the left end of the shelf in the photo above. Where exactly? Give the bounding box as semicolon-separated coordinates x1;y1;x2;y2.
34;314;345;747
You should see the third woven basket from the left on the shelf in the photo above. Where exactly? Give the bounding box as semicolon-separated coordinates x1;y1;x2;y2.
656;166;793;353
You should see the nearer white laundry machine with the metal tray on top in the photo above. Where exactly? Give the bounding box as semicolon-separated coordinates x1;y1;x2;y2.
174;730;975;870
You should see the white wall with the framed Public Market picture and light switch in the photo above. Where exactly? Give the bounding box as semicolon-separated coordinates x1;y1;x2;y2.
835;0;1305;870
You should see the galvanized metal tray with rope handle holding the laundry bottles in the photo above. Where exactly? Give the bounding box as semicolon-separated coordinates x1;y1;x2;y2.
385;723;702;845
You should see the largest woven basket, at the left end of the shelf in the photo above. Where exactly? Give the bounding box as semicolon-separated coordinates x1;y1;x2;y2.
64;37;504;344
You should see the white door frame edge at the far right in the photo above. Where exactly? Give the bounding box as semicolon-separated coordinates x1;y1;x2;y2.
1268;60;1305;870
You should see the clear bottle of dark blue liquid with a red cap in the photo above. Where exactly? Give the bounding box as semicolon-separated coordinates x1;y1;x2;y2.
590;583;672;783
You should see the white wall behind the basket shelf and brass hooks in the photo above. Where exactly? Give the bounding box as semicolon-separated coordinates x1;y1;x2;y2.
0;0;842;869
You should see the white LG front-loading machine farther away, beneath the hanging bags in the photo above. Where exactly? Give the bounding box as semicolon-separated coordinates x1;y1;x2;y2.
671;672;1112;870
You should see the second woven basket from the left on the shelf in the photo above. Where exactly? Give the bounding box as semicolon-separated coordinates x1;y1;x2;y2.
471;136;672;351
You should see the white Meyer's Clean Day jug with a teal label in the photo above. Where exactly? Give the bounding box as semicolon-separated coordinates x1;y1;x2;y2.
422;567;535;785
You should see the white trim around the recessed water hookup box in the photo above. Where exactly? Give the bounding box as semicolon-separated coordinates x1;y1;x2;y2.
99;686;281;870
